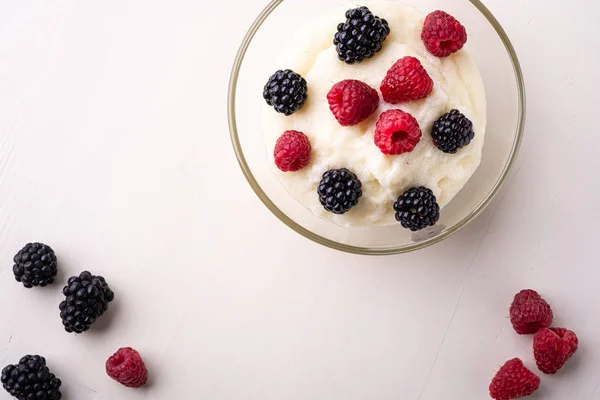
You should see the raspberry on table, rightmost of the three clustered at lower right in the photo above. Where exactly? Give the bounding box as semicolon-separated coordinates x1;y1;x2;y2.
533;328;579;374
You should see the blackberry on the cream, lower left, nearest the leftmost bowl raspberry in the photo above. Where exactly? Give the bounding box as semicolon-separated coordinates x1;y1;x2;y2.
317;168;362;214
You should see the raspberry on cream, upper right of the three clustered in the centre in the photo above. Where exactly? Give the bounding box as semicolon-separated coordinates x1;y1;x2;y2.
380;57;433;104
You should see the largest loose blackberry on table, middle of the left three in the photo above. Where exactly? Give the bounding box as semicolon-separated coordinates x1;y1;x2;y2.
59;271;115;333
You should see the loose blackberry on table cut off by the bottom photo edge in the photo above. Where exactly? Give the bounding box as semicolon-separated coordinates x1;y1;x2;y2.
0;355;62;400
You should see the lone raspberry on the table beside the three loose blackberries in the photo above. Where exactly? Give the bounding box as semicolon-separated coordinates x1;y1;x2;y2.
106;347;148;388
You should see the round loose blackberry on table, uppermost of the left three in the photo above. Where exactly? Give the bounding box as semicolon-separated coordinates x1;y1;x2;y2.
13;243;56;288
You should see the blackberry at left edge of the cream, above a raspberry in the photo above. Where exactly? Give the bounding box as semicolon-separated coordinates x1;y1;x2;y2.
263;69;308;115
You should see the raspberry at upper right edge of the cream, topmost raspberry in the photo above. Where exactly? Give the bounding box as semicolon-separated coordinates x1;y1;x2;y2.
421;10;467;57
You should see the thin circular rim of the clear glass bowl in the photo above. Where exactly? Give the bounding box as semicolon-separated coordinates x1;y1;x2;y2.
227;0;526;255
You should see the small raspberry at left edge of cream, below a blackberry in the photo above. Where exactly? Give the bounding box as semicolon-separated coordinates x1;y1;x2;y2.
273;131;312;172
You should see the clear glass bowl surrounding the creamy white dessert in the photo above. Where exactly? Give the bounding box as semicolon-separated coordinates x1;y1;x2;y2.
228;0;525;255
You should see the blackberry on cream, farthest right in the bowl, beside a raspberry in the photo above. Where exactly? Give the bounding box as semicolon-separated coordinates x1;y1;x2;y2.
431;110;475;154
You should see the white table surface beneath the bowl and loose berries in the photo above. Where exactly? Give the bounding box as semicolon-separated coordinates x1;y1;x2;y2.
0;0;600;400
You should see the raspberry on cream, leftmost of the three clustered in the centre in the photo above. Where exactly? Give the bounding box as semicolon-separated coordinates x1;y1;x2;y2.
327;79;379;126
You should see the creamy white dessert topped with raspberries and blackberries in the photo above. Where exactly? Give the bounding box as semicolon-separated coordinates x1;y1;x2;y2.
263;1;486;230
